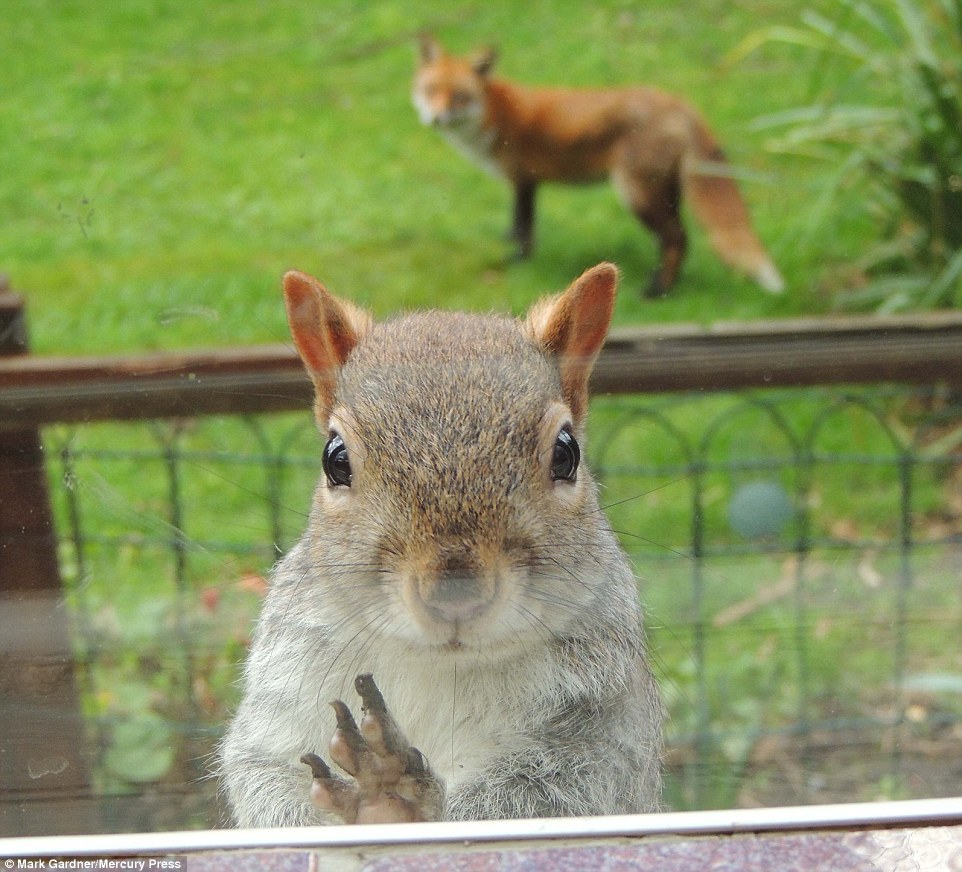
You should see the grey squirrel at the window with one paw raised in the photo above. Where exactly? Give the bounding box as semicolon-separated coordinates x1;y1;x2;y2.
219;263;663;827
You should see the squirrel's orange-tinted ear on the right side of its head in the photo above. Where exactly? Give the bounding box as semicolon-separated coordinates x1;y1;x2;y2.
525;263;618;421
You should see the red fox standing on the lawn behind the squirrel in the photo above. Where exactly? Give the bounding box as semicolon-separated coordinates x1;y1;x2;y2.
412;35;784;297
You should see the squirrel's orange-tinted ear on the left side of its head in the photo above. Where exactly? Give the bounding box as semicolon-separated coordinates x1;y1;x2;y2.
284;270;371;428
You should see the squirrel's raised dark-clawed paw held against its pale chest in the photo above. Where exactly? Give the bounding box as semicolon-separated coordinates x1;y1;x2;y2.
301;675;444;824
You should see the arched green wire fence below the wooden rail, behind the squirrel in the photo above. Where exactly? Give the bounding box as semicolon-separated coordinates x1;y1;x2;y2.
39;388;962;830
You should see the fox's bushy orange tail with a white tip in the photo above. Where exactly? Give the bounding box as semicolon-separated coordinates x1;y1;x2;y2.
685;118;785;294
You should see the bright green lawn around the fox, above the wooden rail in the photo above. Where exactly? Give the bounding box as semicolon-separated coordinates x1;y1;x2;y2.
0;0;872;354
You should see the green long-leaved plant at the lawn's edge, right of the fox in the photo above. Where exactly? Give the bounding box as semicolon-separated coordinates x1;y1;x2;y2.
729;0;962;312
